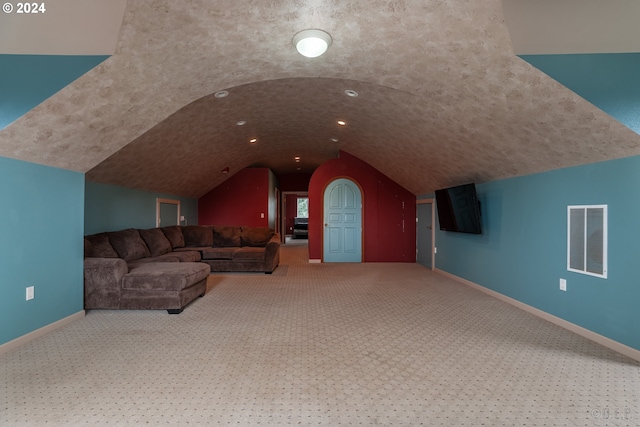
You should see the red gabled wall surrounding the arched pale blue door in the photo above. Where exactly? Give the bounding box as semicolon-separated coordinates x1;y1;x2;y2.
309;151;416;262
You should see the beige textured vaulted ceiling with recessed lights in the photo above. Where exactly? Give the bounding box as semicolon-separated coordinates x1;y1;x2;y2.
0;0;640;197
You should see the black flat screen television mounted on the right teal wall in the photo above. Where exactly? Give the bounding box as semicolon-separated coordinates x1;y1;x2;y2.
436;184;482;234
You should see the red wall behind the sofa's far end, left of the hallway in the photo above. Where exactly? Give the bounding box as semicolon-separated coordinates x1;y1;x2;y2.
198;168;271;227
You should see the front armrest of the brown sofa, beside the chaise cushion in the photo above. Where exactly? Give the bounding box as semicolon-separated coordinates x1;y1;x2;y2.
84;258;129;309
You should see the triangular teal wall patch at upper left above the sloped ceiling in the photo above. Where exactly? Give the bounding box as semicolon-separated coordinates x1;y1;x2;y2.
0;55;108;129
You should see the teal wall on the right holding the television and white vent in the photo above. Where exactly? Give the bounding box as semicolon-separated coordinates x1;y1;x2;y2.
436;157;640;350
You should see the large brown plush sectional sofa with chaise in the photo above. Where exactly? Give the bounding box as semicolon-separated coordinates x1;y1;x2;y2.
84;226;280;313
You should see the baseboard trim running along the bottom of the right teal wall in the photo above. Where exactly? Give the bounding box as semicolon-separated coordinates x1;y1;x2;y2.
434;268;640;362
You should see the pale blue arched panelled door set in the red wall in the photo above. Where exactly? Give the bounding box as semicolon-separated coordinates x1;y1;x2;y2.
323;178;362;262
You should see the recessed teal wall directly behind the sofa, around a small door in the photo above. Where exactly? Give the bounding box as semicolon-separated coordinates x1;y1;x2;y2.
84;182;198;234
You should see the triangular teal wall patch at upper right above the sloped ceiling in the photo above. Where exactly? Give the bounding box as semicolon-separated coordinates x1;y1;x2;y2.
521;53;640;133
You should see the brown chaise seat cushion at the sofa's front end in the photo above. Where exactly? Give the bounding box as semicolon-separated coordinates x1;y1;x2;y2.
122;262;211;291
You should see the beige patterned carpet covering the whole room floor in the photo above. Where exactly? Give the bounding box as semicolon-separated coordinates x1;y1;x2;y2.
0;241;640;426
